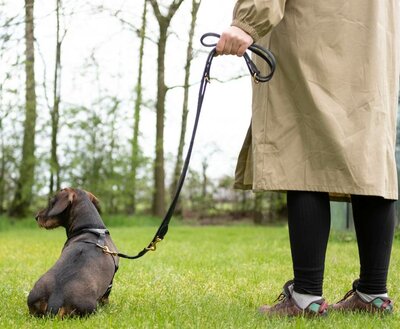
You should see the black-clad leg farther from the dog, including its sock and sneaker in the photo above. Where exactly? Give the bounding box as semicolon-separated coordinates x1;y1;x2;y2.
332;195;395;314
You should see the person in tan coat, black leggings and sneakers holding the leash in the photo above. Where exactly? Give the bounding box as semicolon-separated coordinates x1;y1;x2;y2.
216;0;400;316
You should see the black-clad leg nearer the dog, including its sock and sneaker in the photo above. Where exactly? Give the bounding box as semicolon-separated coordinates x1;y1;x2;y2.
260;191;330;316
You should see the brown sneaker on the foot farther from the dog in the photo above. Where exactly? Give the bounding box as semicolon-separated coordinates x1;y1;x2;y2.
331;279;393;314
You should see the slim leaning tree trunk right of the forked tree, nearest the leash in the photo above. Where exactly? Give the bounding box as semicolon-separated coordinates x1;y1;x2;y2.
171;0;201;195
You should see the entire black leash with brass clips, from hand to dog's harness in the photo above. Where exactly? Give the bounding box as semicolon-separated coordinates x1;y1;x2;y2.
108;33;276;259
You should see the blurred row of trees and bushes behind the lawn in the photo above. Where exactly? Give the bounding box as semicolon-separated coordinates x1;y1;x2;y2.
0;0;285;223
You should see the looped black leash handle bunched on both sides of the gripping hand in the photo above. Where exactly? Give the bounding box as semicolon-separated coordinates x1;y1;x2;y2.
200;32;276;83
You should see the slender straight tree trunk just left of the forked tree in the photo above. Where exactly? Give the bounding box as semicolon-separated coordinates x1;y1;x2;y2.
127;0;147;214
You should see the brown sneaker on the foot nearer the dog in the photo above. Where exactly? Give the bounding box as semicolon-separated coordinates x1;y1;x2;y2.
259;280;328;317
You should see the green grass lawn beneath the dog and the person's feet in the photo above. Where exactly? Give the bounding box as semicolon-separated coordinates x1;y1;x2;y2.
0;220;400;329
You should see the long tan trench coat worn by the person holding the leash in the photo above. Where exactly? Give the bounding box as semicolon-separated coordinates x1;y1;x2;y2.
232;0;400;199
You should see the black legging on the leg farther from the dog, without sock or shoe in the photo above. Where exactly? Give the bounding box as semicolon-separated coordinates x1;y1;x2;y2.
351;195;395;295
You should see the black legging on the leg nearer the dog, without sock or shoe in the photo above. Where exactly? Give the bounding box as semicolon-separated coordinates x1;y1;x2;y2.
287;191;331;296
